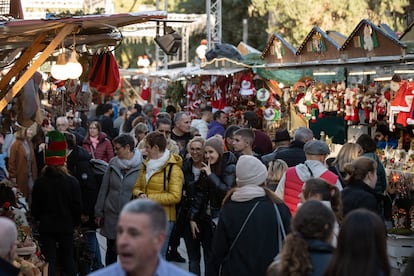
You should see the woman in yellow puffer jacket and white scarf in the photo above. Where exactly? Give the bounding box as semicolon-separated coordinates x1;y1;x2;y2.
132;131;184;258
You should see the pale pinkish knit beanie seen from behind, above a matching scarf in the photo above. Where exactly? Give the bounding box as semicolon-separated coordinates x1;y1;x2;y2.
236;155;267;187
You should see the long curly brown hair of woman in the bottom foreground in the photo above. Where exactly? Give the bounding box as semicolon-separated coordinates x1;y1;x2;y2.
280;200;335;276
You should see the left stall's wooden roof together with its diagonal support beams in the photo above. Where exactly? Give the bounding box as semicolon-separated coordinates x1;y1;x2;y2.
0;11;167;111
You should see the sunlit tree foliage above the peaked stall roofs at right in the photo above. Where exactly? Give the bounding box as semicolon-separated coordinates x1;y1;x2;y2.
252;0;409;47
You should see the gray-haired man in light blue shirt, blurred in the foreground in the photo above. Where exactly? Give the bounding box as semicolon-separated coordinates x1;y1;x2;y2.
91;199;193;276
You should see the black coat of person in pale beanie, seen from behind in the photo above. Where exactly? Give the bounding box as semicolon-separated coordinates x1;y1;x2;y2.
206;196;290;276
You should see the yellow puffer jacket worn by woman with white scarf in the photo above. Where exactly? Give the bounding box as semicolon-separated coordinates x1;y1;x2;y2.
132;153;184;221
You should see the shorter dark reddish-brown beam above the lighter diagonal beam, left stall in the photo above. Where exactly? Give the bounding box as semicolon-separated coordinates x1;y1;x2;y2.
0;33;46;96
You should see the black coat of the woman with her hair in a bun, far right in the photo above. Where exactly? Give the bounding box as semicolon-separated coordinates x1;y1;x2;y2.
341;181;381;217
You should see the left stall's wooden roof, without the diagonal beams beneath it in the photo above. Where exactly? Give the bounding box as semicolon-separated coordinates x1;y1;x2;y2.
0;11;167;57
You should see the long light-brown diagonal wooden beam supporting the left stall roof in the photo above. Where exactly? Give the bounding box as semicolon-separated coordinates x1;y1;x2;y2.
0;24;76;111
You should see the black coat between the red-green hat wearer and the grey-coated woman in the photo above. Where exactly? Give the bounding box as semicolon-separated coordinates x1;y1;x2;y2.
66;146;100;229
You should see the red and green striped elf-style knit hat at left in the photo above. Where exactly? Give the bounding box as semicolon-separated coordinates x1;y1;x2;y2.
45;130;67;166
